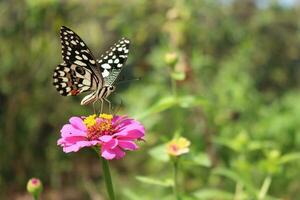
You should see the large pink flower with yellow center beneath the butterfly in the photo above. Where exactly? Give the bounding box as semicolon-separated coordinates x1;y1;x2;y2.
57;114;145;160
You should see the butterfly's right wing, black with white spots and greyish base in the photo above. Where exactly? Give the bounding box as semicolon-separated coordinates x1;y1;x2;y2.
97;38;130;85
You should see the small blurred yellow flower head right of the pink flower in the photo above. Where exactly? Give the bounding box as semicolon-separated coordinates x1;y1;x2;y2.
167;137;191;156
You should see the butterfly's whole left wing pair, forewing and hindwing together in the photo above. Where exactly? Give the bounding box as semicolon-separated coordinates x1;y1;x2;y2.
53;26;103;96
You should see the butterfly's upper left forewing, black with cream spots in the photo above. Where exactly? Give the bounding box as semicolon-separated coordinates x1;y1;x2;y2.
60;26;103;87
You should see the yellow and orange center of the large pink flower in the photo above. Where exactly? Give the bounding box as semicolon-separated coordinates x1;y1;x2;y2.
84;114;114;140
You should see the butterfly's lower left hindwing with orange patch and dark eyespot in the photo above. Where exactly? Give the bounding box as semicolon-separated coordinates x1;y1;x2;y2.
53;63;97;96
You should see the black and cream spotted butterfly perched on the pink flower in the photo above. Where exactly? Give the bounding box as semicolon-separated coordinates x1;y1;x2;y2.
53;26;130;105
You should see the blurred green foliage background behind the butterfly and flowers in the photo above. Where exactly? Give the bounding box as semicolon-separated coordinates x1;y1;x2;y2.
0;0;300;200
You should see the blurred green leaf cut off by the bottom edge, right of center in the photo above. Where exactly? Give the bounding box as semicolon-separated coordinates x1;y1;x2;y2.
194;188;234;200
